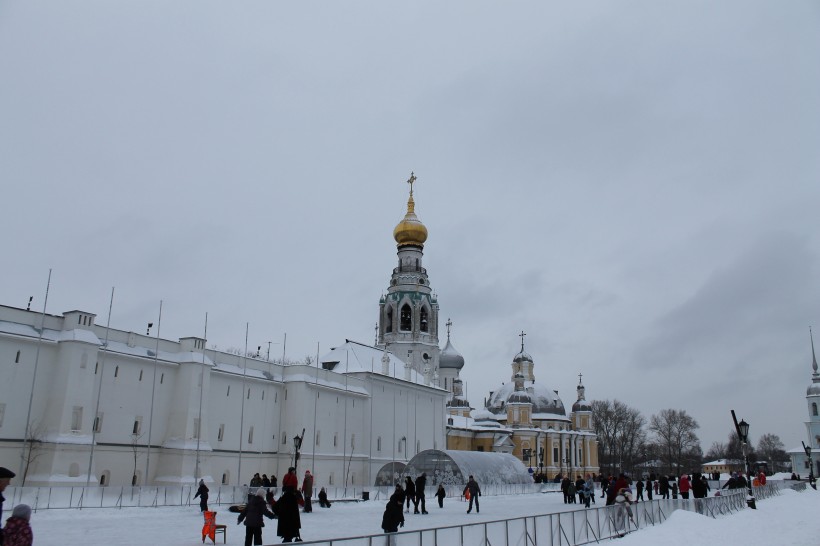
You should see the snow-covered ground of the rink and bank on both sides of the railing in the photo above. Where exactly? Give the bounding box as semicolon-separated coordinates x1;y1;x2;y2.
12;482;820;546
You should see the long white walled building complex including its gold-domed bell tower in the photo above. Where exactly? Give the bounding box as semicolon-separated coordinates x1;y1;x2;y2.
0;177;449;487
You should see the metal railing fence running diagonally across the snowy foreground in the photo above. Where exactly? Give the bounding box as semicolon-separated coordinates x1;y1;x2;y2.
292;484;782;546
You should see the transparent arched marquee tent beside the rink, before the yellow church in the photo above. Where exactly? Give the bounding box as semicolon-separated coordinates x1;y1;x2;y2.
404;449;533;485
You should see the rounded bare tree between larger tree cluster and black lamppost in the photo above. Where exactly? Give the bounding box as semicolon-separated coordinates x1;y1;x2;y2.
649;409;702;475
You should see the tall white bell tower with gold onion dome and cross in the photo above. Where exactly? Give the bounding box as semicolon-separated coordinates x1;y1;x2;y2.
376;173;439;381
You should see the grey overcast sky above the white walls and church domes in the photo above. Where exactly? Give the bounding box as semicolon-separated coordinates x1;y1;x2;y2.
0;0;820;451
